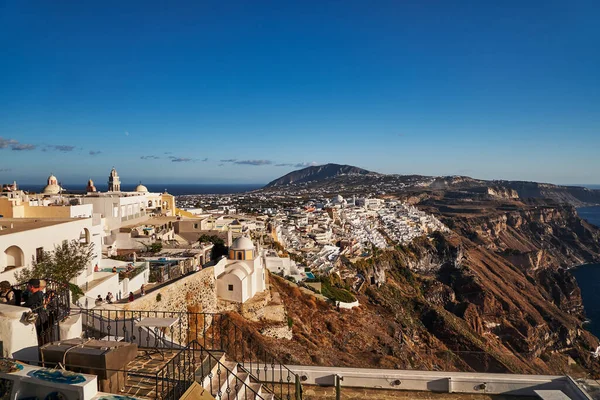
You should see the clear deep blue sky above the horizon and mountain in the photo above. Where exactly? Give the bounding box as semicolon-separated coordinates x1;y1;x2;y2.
0;0;600;183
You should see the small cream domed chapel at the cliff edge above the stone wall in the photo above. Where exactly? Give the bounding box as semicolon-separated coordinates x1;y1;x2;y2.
214;236;267;303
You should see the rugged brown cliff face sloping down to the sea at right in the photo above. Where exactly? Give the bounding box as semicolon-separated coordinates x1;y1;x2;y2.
244;206;600;376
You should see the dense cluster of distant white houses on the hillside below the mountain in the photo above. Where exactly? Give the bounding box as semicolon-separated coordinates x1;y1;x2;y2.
272;195;447;273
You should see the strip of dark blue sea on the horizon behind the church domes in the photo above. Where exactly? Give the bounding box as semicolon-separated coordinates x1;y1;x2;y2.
19;183;264;196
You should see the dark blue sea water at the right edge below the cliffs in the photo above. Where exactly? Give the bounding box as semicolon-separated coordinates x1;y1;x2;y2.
571;206;600;337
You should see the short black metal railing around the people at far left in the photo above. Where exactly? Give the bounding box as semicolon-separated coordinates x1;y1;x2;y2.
12;280;71;346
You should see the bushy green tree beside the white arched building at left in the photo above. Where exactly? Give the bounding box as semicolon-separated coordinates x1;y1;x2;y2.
15;240;94;283
